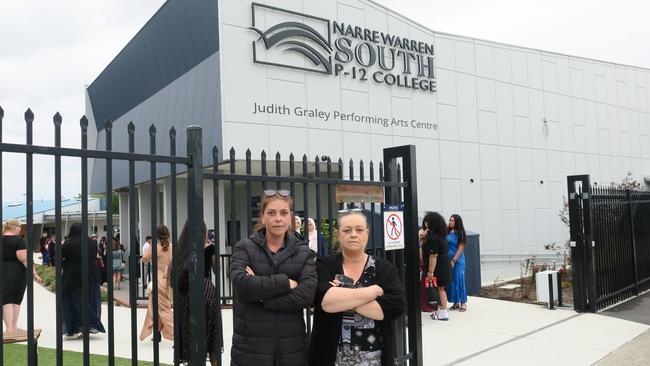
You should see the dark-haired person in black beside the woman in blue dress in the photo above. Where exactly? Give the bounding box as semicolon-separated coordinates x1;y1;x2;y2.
420;212;451;320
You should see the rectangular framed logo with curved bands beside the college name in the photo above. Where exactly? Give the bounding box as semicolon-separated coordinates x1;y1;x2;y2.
250;3;333;74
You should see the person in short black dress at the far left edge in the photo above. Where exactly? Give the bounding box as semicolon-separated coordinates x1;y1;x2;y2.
0;220;41;333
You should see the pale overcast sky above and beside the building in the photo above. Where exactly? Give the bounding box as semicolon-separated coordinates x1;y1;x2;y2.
0;0;650;201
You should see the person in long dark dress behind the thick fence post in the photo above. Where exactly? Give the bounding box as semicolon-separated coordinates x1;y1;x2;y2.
168;222;223;366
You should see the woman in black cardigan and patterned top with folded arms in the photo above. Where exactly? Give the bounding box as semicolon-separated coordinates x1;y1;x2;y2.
309;211;405;366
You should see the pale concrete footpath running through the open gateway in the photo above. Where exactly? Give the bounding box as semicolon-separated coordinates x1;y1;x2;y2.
19;285;650;366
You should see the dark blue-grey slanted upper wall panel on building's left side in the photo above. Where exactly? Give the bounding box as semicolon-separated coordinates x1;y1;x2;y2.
88;0;219;130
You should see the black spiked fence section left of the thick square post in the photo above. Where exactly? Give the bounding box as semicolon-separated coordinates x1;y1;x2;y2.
0;108;190;366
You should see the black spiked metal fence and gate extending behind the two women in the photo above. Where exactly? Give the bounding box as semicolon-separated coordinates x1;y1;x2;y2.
0;104;423;366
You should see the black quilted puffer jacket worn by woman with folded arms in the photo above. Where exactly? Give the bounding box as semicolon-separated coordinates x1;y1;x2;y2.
230;232;317;366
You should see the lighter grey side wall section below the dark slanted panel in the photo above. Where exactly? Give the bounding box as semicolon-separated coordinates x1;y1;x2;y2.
91;52;223;194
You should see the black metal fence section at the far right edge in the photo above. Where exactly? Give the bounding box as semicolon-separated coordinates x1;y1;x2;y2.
568;175;650;312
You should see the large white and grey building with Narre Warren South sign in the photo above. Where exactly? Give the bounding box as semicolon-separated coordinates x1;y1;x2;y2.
87;0;650;282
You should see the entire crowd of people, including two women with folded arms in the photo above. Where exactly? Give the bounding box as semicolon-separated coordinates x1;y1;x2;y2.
2;190;467;366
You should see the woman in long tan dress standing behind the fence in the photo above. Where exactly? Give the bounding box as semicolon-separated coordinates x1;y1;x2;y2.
140;225;174;341
